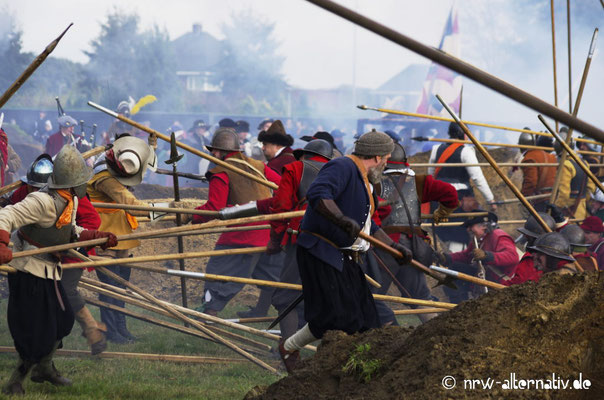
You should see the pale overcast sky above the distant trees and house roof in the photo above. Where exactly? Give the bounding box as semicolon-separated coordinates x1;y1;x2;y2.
0;0;452;88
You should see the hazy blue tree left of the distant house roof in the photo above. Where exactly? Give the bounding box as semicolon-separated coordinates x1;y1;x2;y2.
79;10;180;111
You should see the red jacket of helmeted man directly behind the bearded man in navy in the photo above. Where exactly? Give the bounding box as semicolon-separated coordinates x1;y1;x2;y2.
266;156;329;245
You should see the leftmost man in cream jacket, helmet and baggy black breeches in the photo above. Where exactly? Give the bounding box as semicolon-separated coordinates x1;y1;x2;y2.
0;146;117;394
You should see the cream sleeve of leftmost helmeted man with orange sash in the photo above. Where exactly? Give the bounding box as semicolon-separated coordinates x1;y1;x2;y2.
0;192;57;233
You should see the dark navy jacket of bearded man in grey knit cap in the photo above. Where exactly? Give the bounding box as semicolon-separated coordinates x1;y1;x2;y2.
297;157;379;271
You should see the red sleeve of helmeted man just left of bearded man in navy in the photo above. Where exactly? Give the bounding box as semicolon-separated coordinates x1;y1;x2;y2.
270;162;304;238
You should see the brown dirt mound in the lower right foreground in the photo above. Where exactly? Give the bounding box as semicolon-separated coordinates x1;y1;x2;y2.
247;274;604;400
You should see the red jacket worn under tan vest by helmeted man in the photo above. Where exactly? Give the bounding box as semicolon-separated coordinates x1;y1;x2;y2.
193;156;281;247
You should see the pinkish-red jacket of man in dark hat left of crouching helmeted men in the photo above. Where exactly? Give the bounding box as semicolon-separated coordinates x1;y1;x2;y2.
451;229;518;284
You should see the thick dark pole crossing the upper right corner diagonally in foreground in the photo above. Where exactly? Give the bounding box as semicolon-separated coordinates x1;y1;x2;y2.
306;0;604;142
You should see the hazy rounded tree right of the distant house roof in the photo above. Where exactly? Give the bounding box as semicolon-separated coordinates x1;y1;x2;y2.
219;10;287;113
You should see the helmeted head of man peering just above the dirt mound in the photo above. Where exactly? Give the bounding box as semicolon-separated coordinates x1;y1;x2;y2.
529;232;577;275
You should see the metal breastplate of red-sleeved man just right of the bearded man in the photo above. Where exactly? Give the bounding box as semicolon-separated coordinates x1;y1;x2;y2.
380;175;421;227
